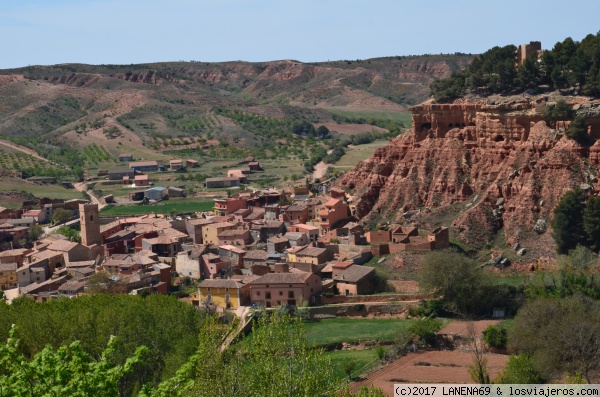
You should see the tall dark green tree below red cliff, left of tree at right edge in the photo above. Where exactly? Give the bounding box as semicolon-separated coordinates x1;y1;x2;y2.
551;189;586;254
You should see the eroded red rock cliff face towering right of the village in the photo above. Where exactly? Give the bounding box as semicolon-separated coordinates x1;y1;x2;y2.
336;97;600;254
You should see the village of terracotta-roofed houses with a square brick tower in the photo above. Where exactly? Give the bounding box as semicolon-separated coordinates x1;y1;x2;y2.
0;152;449;312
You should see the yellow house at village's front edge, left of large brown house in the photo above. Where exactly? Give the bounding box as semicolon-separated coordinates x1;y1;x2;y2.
198;279;250;310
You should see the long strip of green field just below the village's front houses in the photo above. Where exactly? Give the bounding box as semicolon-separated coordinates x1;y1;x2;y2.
304;318;412;346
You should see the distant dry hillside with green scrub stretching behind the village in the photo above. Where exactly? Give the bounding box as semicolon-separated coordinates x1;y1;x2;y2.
0;55;472;157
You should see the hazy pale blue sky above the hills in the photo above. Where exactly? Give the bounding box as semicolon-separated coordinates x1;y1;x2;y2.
0;0;600;68
